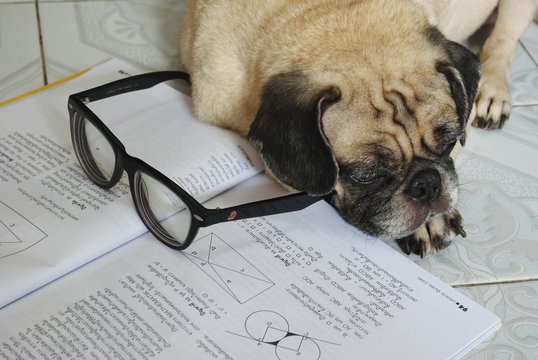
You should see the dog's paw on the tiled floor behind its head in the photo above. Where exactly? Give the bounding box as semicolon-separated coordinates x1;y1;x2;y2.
473;66;512;130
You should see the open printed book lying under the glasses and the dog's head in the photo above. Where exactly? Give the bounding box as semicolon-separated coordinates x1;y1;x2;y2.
0;60;499;360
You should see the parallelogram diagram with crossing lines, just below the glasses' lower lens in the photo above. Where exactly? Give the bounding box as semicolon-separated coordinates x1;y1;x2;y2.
182;233;275;304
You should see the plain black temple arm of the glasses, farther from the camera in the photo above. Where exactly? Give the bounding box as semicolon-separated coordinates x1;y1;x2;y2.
73;71;190;103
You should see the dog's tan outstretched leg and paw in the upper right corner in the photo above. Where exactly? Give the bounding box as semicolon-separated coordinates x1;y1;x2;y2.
473;0;538;130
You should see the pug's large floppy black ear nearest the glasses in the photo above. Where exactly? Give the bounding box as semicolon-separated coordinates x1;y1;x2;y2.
248;71;340;195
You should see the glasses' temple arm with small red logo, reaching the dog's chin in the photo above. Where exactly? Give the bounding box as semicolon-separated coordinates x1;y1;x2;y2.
205;193;333;226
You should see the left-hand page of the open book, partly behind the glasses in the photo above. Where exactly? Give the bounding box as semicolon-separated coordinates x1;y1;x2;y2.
0;60;262;307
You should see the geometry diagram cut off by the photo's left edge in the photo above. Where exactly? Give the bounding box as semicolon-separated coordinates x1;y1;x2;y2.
0;201;47;259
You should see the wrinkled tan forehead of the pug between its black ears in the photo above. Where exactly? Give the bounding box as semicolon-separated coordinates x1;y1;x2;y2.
324;71;464;164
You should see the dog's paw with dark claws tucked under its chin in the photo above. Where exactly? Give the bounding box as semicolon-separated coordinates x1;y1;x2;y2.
396;210;467;258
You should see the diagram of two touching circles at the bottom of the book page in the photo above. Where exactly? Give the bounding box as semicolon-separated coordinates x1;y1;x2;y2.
228;310;338;360
